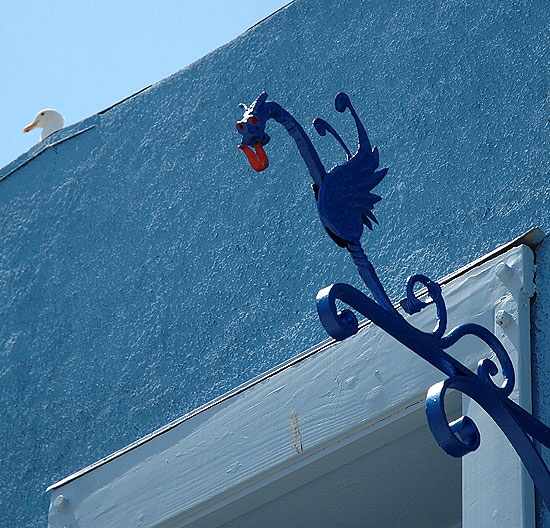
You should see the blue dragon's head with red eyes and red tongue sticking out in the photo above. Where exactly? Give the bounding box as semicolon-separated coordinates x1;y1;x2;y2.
237;92;269;172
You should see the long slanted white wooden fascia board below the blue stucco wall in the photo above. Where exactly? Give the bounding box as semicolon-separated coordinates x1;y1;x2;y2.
49;245;534;528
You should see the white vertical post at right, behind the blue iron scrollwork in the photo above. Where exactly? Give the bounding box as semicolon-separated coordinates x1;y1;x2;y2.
462;246;535;528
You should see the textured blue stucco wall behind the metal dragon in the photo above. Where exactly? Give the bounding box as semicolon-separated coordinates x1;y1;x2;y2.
0;0;550;527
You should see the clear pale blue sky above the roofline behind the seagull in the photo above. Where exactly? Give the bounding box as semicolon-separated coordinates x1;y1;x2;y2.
0;0;289;167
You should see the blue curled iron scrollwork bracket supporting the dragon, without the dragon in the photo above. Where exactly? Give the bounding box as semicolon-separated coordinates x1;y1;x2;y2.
317;275;550;507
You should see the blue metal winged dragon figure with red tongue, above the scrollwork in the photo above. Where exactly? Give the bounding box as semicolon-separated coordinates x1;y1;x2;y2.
237;92;392;314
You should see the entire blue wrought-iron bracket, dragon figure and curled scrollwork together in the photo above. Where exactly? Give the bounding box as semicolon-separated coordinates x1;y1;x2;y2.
237;93;550;508
